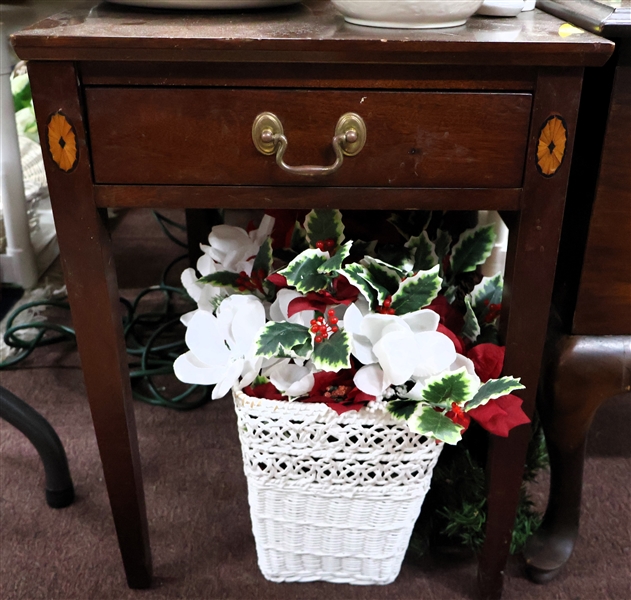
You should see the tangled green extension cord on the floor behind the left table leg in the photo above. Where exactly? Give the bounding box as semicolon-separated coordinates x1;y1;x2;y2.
0;211;212;410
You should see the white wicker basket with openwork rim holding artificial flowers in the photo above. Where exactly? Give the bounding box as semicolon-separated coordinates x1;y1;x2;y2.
233;390;443;584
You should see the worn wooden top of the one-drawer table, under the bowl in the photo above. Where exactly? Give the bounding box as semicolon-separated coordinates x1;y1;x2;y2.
12;0;613;66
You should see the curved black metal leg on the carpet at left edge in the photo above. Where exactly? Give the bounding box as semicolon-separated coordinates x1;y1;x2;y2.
0;387;74;508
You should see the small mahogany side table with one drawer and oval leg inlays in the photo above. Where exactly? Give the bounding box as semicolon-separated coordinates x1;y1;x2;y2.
8;0;613;598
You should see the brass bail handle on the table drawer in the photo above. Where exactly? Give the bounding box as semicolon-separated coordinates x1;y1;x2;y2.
252;112;366;177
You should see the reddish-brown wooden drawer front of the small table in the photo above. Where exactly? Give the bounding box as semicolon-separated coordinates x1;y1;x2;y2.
86;87;532;188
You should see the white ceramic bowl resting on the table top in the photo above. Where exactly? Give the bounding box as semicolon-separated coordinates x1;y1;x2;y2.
331;0;483;29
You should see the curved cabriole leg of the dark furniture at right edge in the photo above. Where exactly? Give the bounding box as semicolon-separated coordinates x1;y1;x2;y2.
524;336;631;583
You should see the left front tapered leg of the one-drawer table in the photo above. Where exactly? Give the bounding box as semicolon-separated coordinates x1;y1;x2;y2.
29;62;151;588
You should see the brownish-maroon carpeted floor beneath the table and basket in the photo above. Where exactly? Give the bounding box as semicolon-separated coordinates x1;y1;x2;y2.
0;211;631;600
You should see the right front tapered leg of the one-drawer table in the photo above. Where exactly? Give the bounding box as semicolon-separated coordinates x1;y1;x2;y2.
478;69;582;599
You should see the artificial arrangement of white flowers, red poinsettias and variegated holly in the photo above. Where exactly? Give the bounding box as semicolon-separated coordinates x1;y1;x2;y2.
174;209;528;444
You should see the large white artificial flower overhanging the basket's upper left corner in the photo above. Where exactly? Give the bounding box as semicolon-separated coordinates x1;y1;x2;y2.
173;295;265;399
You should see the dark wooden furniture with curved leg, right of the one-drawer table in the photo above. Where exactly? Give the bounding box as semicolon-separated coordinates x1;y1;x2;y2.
524;0;631;582
